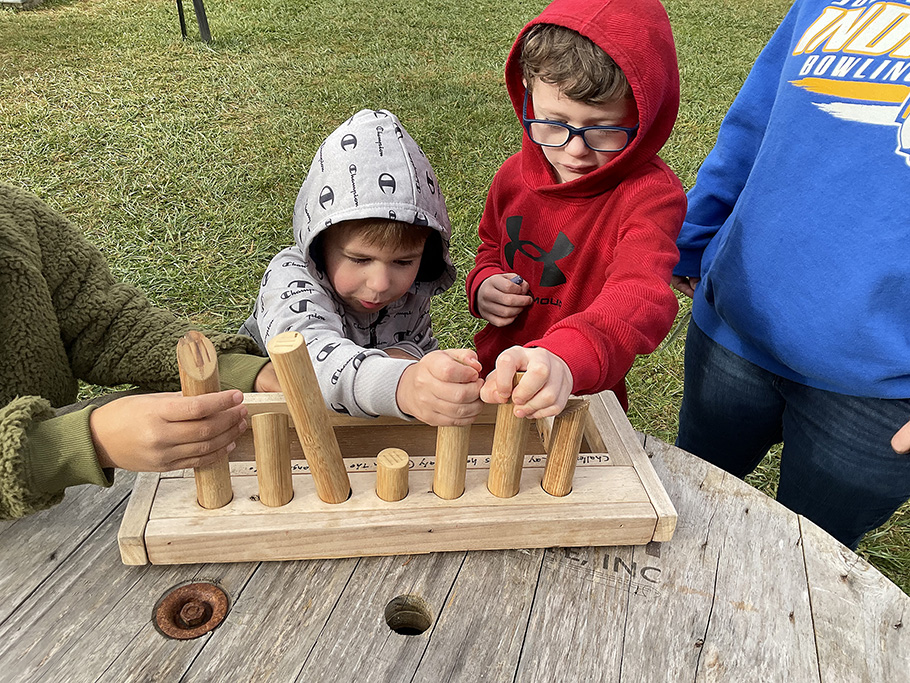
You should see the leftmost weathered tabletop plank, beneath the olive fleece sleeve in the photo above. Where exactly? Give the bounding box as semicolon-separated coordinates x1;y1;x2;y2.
0;472;133;623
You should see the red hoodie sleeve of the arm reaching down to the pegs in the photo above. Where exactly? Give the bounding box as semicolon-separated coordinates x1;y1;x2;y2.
525;176;686;393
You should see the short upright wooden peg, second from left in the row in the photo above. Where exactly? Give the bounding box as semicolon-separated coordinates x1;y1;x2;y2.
252;413;294;507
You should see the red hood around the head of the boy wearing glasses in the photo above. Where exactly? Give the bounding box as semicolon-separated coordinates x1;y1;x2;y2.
506;0;679;197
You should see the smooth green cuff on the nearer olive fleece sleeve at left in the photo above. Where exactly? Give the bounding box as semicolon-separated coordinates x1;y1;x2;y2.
26;406;114;493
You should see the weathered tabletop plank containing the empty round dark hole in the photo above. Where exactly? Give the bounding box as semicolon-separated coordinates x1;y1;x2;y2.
297;553;465;683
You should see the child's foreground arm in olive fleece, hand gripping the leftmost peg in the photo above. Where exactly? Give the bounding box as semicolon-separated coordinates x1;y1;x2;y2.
0;390;247;519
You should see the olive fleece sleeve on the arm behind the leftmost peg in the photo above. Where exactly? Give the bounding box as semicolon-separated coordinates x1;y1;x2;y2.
37;195;267;390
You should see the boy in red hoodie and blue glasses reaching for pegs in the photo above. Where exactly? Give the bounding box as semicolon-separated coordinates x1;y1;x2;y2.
467;0;686;418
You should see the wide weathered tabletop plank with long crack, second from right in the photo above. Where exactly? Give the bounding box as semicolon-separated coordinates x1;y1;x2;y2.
622;440;819;683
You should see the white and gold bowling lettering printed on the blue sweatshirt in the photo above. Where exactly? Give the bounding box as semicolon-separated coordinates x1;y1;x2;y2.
790;0;910;165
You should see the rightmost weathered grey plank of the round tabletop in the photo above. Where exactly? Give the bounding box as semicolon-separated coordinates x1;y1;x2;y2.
800;517;910;683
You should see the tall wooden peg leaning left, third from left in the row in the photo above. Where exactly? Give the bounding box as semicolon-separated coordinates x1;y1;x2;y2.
268;332;351;503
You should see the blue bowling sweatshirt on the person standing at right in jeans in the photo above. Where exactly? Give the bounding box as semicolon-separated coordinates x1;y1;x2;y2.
674;0;910;398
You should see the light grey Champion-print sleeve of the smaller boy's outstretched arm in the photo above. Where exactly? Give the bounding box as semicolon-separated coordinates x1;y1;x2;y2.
253;247;414;419
